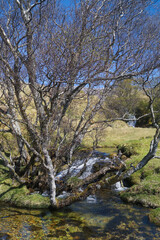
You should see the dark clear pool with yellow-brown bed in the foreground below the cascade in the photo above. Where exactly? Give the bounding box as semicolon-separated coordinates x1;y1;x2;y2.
0;190;160;240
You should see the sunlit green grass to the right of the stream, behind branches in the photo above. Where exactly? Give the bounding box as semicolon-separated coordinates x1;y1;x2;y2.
84;121;160;225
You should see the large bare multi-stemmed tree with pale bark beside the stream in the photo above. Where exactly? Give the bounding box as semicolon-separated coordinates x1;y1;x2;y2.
0;0;159;208
